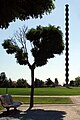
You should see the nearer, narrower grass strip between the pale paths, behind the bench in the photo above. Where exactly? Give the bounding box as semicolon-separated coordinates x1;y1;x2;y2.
13;97;72;104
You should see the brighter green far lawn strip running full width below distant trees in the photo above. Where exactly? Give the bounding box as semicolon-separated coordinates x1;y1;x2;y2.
0;87;80;96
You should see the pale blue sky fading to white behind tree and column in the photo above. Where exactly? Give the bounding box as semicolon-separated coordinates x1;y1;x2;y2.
0;0;80;84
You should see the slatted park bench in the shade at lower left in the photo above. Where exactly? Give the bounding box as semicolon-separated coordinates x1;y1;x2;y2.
0;94;22;113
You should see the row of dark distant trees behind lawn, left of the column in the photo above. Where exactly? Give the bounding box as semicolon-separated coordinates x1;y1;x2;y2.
0;72;59;88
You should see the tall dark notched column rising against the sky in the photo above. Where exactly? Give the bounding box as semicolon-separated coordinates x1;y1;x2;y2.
65;4;69;86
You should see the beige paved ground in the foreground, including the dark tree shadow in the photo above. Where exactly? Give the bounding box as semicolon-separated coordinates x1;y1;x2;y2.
0;96;80;120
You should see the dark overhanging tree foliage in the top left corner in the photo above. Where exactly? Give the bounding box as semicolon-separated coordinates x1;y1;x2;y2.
0;0;55;28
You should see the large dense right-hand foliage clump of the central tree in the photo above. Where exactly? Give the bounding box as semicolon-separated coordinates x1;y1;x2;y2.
26;25;64;66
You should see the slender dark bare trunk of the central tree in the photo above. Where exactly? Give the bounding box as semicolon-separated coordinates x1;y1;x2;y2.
30;67;34;109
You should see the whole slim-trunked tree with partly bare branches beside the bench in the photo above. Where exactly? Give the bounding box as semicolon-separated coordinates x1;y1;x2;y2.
2;25;64;108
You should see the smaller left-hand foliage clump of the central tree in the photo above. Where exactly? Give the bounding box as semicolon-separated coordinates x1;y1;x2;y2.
2;39;27;65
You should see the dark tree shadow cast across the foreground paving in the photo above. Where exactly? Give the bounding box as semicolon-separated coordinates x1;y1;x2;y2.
0;109;66;120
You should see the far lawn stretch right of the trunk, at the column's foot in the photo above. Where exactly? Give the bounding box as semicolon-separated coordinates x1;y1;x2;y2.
35;88;80;96
